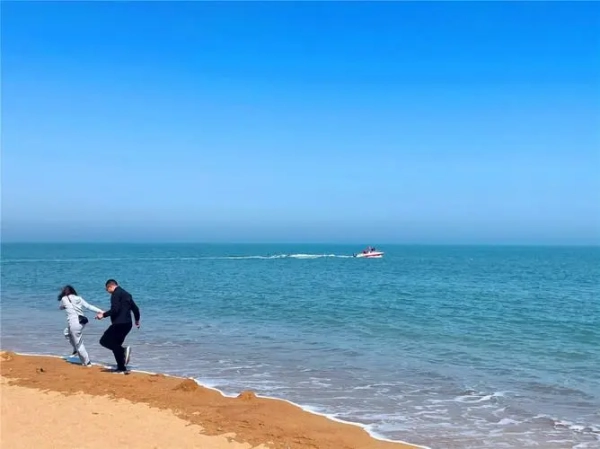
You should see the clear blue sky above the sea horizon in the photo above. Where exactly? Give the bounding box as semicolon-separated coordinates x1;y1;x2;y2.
2;2;600;244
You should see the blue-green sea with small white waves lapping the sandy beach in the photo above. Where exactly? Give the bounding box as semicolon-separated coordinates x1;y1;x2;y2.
0;242;600;449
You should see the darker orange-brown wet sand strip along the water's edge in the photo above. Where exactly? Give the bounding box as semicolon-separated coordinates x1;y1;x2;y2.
0;350;427;449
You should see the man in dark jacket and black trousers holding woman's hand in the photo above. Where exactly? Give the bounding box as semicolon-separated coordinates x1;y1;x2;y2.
96;279;140;373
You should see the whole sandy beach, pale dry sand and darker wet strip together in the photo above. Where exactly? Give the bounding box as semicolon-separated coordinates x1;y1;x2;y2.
0;352;416;449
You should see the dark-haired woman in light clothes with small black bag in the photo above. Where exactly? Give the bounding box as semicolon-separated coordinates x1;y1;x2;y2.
58;285;104;366
